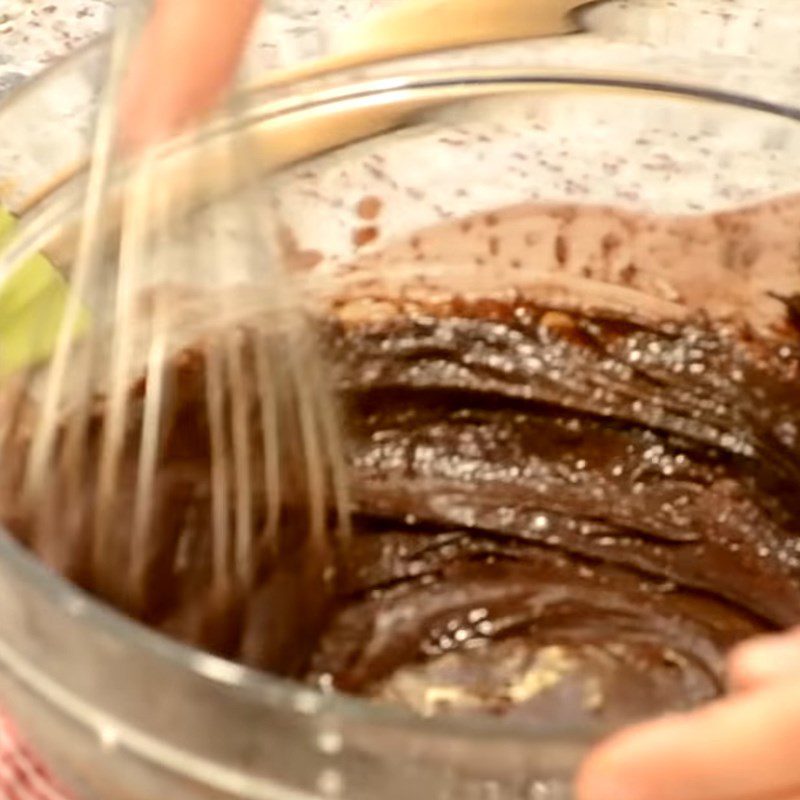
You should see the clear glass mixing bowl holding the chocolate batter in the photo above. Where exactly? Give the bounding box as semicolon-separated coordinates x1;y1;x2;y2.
0;36;800;800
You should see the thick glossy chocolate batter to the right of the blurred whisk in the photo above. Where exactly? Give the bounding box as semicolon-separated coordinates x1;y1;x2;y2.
312;302;800;722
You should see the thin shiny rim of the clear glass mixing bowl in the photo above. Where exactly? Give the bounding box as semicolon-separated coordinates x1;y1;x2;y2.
0;42;800;756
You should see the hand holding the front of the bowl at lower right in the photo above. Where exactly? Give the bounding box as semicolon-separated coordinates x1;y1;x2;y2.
577;630;800;800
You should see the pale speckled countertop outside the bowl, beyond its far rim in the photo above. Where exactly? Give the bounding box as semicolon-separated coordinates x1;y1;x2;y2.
0;0;800;95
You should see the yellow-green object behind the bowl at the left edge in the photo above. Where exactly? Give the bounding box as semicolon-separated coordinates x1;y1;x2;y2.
0;207;89;378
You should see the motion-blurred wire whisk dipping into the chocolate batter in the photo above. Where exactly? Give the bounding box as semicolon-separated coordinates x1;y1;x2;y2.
0;4;348;660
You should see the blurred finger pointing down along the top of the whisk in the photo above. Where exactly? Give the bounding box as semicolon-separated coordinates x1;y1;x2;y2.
120;0;260;149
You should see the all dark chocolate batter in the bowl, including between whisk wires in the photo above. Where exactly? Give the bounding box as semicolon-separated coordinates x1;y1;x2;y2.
0;209;800;724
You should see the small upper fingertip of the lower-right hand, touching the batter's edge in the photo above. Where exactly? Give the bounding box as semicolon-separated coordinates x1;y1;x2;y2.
728;628;800;691
